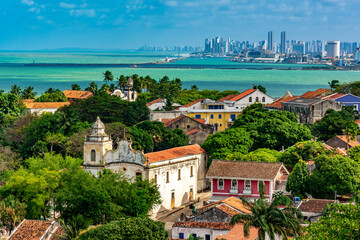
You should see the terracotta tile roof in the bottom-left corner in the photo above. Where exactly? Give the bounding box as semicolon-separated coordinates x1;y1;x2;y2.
9;220;51;240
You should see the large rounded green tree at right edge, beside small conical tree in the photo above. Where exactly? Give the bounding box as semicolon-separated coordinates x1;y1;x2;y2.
310;155;360;199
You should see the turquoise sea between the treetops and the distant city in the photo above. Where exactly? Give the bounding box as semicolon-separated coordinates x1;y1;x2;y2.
0;51;360;97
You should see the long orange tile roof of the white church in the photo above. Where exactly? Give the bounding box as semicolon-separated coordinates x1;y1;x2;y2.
145;144;206;163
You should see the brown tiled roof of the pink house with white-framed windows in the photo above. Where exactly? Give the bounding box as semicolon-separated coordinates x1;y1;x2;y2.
206;160;285;180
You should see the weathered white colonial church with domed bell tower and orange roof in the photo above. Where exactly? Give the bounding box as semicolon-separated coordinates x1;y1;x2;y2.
83;118;208;213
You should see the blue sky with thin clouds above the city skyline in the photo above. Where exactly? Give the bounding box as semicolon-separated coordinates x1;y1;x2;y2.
0;0;360;50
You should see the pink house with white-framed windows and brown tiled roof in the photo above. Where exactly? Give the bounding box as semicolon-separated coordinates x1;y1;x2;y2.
206;160;289;201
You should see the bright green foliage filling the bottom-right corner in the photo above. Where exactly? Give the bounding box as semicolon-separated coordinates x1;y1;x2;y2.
299;204;360;240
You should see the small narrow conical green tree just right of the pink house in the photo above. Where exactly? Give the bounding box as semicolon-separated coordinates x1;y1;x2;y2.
286;160;310;198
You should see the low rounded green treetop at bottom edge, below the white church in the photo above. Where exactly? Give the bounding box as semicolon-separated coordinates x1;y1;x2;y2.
78;218;168;240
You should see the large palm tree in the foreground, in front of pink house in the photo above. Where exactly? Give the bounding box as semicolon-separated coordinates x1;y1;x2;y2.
230;182;302;240
